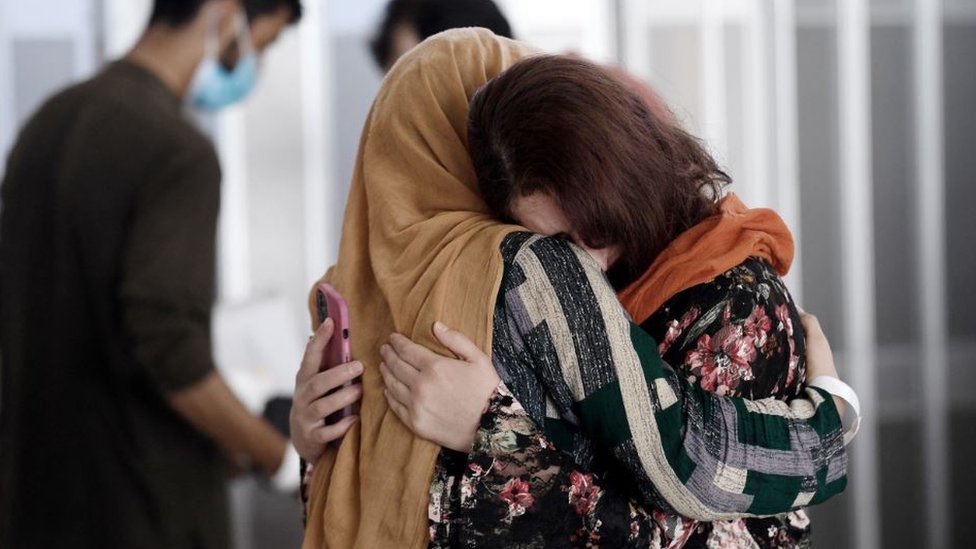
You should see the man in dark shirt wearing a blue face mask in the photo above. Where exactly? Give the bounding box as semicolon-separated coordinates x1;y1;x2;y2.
0;0;302;549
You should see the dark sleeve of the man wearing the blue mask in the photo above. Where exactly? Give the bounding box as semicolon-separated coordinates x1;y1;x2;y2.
119;148;220;393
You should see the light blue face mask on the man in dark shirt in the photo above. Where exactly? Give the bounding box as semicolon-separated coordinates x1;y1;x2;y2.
190;9;258;111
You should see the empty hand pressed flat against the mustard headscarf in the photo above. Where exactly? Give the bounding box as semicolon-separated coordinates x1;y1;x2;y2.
380;322;500;452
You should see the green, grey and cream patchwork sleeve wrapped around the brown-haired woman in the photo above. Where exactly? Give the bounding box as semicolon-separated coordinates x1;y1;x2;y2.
475;238;846;520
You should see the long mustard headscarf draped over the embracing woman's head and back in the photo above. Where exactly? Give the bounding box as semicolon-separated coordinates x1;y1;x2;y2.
304;29;536;549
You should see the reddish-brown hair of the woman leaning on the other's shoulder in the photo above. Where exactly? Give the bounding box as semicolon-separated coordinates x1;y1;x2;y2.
468;56;730;289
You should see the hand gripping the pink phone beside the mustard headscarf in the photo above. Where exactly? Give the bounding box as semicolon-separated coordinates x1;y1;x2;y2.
289;319;363;465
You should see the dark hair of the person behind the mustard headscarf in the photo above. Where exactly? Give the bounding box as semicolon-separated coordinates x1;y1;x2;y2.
369;0;512;68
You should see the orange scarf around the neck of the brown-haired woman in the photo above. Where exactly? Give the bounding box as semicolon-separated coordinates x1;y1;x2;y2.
618;193;793;323
